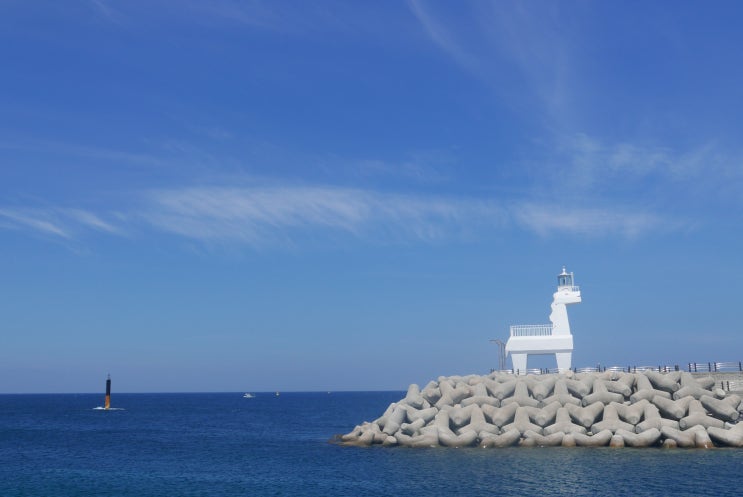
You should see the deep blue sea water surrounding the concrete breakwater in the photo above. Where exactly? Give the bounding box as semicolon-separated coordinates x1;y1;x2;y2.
0;392;743;497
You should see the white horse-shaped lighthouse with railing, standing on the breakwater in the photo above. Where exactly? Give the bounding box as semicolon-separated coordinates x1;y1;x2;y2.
506;266;581;374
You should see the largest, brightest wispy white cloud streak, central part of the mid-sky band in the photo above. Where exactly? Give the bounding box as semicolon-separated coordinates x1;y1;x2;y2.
141;186;504;246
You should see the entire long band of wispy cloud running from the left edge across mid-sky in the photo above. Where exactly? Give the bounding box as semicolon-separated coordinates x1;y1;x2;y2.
0;181;680;248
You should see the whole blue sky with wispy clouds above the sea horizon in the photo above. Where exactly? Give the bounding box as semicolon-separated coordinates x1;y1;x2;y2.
0;0;743;392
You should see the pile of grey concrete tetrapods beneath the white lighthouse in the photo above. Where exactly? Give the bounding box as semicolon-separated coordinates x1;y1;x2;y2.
336;370;743;448
